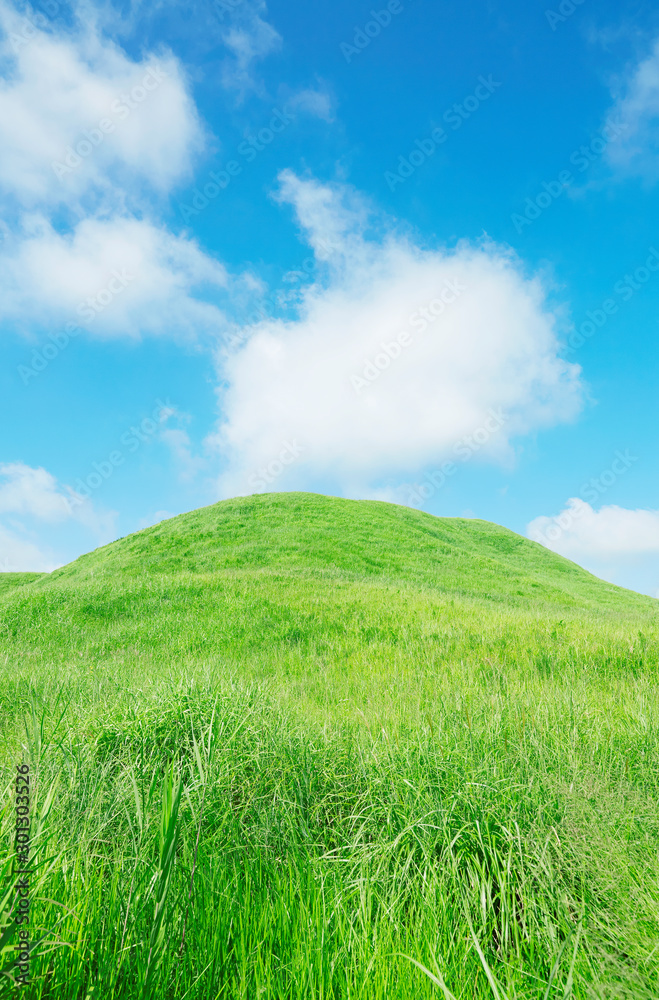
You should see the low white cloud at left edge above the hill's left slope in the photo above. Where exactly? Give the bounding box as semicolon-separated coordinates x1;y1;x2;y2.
0;462;115;573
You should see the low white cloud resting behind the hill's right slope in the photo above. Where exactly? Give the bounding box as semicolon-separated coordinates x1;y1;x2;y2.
526;497;659;595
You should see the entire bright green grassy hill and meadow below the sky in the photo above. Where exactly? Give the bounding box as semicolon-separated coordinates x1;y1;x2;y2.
0;494;659;1000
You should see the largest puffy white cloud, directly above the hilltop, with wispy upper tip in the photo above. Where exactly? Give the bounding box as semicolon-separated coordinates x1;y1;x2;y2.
214;173;582;495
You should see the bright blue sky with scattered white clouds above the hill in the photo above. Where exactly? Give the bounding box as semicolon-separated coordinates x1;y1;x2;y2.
0;0;659;595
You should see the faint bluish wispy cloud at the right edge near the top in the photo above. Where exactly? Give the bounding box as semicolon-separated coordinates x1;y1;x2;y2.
606;38;659;176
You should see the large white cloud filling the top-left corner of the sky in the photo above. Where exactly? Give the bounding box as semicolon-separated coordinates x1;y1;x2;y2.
0;0;203;207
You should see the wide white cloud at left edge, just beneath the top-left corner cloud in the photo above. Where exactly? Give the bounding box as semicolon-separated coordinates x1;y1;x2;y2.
0;217;232;337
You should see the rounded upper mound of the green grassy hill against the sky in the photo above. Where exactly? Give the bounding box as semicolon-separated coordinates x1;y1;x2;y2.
18;493;658;613
